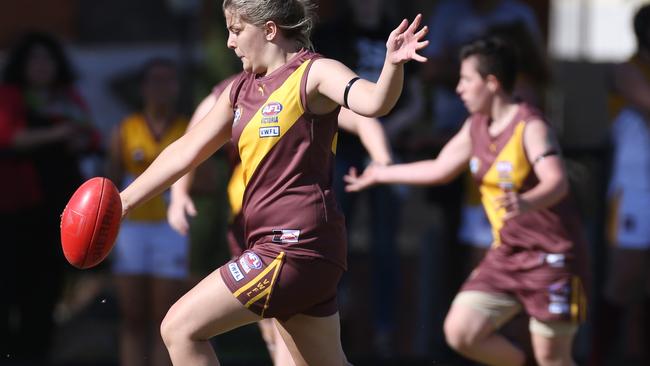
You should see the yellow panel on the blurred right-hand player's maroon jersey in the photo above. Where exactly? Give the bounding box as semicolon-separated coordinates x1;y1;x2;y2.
479;121;531;246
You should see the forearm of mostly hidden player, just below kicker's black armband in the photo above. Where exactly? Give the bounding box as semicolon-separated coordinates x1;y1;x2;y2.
339;108;393;165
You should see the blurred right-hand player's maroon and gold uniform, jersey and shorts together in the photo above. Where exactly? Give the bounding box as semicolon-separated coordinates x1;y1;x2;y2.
463;103;588;322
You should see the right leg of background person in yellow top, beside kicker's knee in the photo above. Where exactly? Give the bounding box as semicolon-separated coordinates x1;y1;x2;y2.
150;277;186;366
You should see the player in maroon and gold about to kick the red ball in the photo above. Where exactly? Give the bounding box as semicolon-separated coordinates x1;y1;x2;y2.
115;0;427;366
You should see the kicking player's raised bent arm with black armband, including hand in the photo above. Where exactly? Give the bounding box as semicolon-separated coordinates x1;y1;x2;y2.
307;14;428;117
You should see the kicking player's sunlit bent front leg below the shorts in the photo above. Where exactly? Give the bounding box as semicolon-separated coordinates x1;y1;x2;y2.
161;269;260;366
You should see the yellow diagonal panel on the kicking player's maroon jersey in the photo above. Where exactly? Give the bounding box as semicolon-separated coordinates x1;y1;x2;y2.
238;60;311;185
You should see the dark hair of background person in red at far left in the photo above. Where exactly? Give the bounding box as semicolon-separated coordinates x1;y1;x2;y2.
2;32;76;87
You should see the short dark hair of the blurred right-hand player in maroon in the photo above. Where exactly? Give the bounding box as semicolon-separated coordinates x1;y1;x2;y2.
460;36;518;93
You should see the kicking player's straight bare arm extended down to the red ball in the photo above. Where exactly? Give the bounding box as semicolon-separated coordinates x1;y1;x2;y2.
121;87;233;214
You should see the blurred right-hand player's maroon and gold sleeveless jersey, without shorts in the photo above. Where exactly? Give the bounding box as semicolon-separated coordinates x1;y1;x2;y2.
470;103;581;266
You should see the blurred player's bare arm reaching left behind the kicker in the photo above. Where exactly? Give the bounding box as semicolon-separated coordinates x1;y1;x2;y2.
343;122;472;192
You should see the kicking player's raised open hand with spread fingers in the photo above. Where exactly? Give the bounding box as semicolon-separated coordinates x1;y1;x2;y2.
386;14;429;65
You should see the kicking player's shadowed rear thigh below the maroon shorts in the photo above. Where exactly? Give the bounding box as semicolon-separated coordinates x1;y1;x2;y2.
278;313;348;366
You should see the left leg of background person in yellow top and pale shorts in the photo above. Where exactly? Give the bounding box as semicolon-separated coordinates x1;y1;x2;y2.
115;275;150;366
